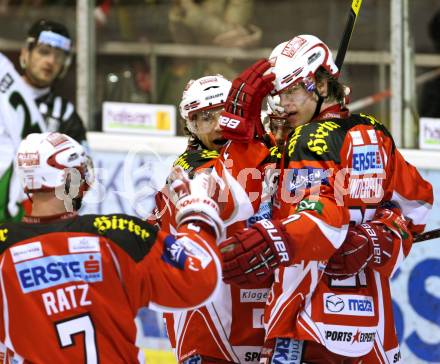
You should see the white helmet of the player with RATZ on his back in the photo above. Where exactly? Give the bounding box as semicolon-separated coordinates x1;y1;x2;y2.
15;133;93;193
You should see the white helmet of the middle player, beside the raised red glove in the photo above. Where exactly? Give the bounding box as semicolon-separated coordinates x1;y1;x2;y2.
179;75;232;121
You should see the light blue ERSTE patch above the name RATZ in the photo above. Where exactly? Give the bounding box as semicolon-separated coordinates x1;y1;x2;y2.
15;253;103;293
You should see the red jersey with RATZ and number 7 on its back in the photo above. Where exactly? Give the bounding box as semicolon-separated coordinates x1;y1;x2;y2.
0;214;221;364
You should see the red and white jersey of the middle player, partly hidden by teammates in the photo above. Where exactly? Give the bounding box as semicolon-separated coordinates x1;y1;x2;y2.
156;142;271;363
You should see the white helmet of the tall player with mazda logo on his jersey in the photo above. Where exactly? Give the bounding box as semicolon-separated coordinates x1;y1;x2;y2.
269;34;339;93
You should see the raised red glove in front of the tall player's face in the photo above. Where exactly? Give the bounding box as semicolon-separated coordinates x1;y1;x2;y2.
219;59;275;142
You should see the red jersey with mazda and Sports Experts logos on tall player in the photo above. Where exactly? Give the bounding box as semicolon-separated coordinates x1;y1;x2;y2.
265;108;433;363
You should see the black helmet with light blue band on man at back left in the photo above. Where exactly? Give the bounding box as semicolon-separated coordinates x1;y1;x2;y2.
20;19;72;78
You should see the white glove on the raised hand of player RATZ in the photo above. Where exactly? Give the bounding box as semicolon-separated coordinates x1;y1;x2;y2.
168;166;224;240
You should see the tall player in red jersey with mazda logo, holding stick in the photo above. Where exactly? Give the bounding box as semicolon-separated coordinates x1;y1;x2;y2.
217;35;433;363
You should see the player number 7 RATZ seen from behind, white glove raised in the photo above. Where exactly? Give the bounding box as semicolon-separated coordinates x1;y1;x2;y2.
0;133;223;363
